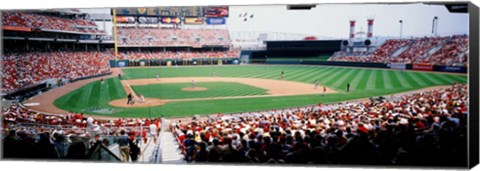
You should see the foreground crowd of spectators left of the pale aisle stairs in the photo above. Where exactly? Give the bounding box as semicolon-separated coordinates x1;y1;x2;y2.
2;104;161;162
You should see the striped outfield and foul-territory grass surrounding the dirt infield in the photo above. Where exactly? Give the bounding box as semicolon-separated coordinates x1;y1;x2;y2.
55;65;467;117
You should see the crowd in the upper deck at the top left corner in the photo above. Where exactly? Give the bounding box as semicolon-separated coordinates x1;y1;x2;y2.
2;11;105;33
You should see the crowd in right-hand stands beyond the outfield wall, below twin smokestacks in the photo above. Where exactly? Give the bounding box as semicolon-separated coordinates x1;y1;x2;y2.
329;35;468;66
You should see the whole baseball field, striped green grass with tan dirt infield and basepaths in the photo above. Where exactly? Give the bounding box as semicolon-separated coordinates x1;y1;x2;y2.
50;65;467;117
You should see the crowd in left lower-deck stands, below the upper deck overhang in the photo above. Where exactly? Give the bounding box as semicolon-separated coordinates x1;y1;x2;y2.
1;51;113;91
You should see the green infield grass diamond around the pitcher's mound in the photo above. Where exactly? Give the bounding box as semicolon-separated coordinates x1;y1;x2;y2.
132;82;267;99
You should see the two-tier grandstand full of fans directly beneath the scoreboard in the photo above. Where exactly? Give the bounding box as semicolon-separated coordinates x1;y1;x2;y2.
117;27;240;60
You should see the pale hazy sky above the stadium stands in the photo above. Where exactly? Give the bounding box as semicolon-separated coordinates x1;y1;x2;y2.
82;4;469;38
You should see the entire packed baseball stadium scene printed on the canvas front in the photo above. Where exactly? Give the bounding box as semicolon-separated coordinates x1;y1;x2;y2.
1;3;469;167
